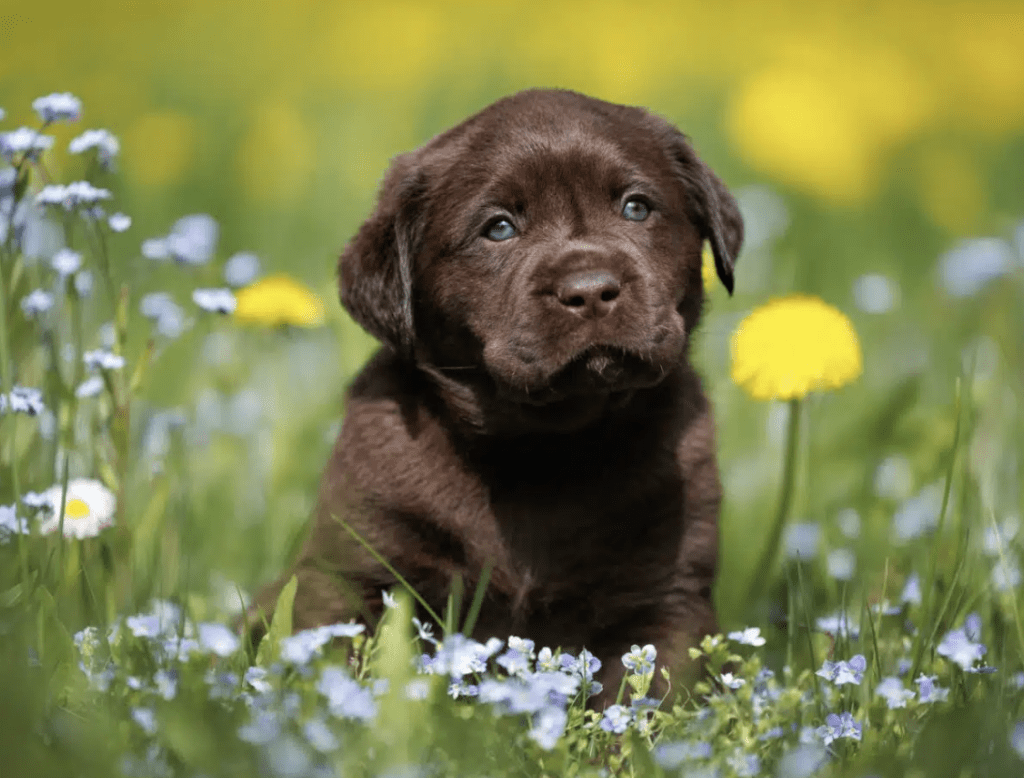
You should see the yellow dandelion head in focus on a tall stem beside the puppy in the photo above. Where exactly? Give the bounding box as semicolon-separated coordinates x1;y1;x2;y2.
732;295;863;400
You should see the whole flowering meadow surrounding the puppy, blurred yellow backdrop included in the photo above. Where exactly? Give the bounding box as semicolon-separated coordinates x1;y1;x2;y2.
0;3;1024;778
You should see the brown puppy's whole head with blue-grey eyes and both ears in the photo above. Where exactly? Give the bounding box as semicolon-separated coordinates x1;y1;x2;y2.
340;90;742;429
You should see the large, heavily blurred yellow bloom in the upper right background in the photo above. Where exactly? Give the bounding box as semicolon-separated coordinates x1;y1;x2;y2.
726;40;938;203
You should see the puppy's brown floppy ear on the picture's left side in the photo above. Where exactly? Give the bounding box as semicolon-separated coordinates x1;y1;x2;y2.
338;155;426;356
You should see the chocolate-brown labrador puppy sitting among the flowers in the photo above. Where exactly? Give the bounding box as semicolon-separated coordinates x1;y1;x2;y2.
253;90;742;696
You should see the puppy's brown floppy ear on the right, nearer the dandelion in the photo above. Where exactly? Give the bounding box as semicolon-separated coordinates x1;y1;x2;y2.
673;133;743;295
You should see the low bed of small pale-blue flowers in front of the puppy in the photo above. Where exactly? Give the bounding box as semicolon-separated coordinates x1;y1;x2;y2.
39;513;1024;776
